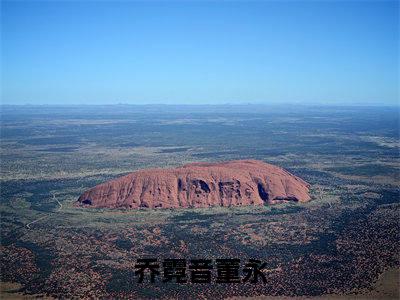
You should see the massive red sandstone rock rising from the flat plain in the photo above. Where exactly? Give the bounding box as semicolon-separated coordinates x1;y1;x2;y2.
77;160;310;209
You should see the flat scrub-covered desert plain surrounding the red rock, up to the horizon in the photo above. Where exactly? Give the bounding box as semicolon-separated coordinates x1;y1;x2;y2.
0;105;400;299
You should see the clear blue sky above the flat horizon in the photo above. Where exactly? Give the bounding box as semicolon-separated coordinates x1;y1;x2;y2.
1;0;399;105
